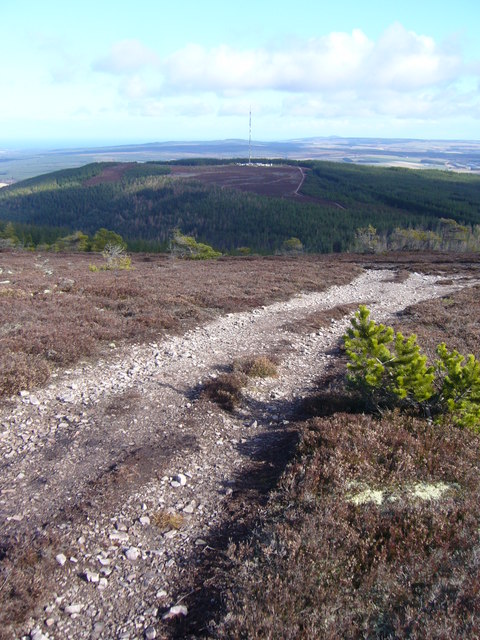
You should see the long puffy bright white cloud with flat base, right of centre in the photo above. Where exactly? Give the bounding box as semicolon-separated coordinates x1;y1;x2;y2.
161;24;462;92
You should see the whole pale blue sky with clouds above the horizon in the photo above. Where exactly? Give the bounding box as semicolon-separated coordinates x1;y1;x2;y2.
0;0;480;147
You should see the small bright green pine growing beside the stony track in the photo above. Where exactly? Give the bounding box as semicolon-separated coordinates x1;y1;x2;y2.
343;306;480;432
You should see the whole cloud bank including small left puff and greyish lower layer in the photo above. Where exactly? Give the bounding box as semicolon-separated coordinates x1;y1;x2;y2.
90;23;479;127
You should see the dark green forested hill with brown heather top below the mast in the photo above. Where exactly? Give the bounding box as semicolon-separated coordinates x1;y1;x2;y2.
0;160;480;253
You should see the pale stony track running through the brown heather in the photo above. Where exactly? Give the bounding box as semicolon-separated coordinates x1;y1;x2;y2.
0;270;472;640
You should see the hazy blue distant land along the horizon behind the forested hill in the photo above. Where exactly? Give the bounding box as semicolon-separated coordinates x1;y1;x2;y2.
0;136;480;183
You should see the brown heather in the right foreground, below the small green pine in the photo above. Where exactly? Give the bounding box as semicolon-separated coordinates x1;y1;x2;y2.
218;414;480;640
